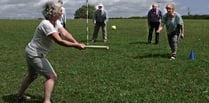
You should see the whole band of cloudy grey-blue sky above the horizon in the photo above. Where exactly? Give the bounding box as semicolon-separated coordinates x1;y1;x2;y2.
0;0;209;18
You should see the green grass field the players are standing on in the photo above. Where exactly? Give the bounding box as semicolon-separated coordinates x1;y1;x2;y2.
0;19;209;103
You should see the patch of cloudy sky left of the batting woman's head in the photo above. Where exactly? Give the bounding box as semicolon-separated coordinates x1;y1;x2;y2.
0;0;40;18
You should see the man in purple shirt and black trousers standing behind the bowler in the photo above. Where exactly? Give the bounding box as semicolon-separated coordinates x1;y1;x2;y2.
148;3;162;44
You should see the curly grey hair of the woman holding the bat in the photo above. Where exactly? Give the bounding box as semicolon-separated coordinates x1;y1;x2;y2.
42;1;62;20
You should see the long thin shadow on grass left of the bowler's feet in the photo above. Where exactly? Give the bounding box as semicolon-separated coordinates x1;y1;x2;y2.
133;54;169;59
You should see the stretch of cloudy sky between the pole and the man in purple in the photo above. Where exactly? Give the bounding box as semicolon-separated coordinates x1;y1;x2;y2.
84;0;151;17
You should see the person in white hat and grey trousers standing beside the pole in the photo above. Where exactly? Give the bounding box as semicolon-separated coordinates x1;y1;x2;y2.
92;3;108;42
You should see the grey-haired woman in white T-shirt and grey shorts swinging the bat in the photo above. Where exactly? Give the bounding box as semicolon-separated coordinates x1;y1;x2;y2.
17;1;85;103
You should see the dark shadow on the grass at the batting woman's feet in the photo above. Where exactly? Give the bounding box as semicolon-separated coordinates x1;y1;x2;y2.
2;94;43;103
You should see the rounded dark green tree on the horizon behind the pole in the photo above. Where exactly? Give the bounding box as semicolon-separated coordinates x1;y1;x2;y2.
74;5;95;19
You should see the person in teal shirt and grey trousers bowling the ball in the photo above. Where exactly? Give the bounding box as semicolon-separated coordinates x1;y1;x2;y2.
157;3;184;60
